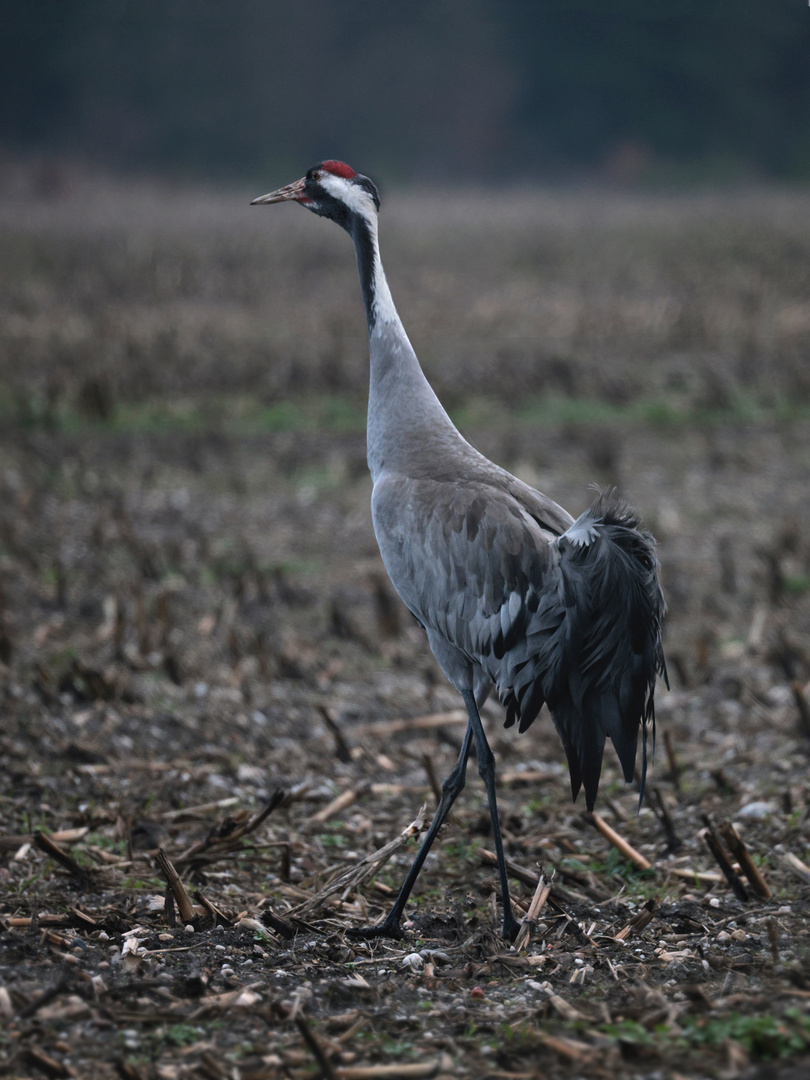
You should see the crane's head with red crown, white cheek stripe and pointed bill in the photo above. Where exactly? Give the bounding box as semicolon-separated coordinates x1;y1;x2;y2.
251;161;380;232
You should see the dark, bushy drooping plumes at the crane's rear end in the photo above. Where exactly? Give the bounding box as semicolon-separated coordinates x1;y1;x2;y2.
504;492;666;810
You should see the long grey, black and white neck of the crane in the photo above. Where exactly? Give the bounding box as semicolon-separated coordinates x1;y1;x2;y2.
350;210;474;481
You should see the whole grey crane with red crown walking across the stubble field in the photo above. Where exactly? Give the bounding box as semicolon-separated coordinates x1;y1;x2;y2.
252;161;666;941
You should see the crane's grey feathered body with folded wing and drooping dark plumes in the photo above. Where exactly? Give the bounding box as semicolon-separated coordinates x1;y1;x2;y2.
373;473;665;809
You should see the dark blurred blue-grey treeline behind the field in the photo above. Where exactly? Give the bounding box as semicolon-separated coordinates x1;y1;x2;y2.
0;0;810;180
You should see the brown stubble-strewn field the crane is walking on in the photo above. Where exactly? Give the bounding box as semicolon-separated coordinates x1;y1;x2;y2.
0;164;810;1080
